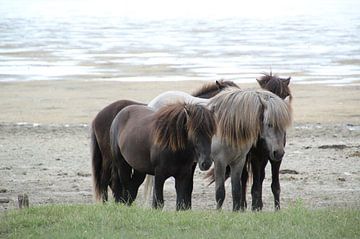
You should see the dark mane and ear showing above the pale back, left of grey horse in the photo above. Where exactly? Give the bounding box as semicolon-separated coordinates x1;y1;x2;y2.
191;80;239;98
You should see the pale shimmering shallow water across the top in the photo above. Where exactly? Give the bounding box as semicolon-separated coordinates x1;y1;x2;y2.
0;0;360;84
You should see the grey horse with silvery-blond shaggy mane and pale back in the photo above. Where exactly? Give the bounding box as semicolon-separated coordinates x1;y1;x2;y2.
148;88;292;211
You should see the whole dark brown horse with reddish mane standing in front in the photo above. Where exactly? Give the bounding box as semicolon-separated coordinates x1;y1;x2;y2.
110;102;216;210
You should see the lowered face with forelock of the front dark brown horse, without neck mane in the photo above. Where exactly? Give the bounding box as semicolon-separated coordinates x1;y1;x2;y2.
184;104;216;171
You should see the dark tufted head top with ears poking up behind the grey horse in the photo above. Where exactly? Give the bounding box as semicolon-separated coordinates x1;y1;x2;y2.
256;72;292;102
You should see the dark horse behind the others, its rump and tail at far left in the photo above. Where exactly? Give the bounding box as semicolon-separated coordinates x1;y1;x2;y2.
90;80;238;202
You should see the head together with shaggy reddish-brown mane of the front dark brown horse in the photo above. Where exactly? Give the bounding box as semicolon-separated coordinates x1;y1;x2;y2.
153;103;216;170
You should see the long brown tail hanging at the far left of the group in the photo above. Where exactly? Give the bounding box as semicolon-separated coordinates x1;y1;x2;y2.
91;128;103;201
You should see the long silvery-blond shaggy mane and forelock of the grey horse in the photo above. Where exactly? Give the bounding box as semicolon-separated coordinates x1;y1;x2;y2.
209;89;292;148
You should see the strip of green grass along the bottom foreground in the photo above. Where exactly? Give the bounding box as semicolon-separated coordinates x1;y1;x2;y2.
0;204;360;239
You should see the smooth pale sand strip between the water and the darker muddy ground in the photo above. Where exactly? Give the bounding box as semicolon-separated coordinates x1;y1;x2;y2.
0;80;360;124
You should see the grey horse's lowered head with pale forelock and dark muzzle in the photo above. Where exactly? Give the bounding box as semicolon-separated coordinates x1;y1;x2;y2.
260;92;292;161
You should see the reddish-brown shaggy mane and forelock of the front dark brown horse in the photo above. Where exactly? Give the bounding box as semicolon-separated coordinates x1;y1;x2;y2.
152;103;216;151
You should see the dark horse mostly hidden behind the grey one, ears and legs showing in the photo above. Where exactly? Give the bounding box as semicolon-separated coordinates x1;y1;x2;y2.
205;72;292;211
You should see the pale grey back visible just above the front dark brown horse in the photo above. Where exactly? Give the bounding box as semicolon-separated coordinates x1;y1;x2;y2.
148;91;209;110
